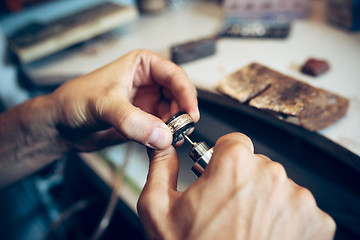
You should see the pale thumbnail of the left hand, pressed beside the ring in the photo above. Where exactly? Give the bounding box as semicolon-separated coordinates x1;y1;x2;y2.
148;125;172;149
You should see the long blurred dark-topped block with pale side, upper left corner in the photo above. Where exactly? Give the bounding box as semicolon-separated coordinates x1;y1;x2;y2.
9;2;138;63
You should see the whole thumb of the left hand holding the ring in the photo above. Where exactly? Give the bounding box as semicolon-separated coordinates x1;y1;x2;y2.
104;100;172;149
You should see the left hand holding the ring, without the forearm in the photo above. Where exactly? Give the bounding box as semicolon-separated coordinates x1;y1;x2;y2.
53;50;199;151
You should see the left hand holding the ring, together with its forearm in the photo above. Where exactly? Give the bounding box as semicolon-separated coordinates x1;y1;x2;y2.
0;50;199;188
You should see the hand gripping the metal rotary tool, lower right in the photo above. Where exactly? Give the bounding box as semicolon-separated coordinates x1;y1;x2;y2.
138;133;335;240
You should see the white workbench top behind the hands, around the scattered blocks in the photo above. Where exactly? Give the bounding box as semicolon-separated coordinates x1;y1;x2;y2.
4;1;360;155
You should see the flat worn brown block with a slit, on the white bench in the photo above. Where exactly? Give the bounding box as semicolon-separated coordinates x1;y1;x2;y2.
217;63;349;131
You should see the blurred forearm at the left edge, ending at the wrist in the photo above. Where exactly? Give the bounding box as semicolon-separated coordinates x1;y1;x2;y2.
0;96;69;188
